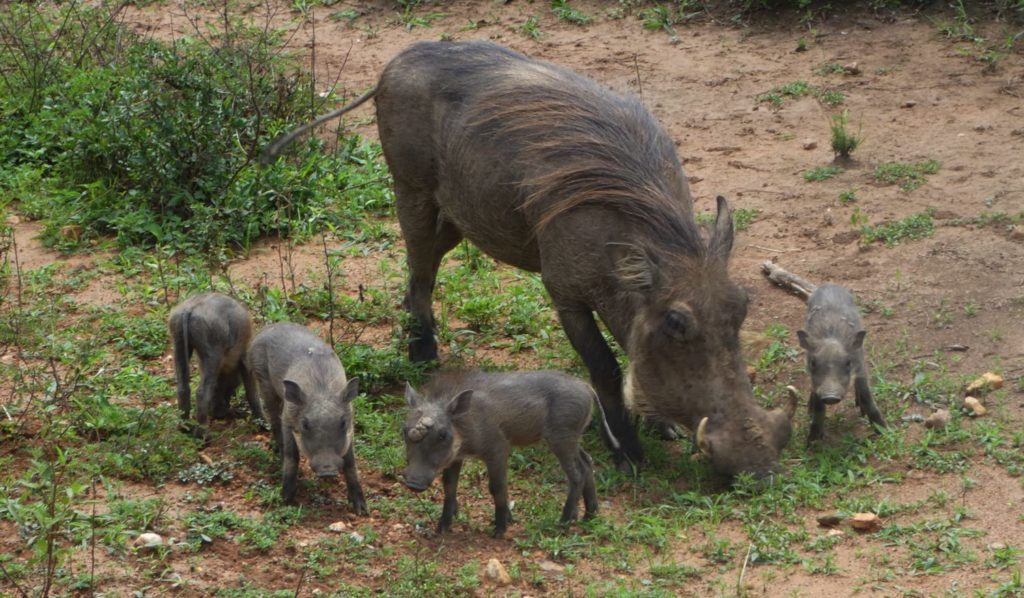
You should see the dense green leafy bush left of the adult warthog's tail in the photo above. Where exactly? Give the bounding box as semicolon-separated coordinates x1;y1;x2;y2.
0;6;389;250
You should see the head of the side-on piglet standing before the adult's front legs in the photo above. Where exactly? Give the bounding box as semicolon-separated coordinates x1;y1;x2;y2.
401;384;473;492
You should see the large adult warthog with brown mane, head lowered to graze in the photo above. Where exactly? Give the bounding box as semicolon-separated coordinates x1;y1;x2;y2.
265;42;791;476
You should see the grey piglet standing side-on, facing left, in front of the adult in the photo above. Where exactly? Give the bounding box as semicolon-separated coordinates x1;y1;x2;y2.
402;371;613;537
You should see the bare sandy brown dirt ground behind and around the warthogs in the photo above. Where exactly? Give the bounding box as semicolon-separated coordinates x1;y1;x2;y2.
8;0;1024;596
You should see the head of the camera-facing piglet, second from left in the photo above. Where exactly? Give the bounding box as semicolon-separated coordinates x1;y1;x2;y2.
284;377;359;477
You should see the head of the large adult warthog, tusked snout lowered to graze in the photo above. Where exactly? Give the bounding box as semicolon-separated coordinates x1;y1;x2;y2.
613;198;795;478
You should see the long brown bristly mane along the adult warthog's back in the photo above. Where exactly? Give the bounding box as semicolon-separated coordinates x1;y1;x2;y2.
466;60;708;256
